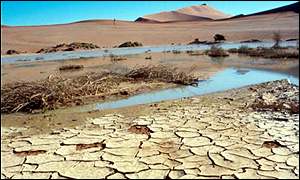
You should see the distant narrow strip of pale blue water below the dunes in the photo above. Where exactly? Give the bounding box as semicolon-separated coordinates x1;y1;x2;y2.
1;41;297;63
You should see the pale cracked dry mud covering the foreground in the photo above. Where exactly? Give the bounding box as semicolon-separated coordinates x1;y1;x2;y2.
1;80;299;179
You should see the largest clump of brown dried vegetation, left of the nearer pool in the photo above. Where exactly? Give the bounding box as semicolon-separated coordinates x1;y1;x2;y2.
1;65;197;113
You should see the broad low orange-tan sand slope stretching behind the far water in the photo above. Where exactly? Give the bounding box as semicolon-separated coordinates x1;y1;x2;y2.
1;2;299;54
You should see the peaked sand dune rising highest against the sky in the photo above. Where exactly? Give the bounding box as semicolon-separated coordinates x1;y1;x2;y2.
136;5;230;22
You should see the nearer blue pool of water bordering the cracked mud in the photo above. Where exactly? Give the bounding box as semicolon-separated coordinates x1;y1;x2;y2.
55;68;299;112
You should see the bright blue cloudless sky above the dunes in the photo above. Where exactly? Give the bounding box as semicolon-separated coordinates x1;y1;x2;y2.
1;1;297;26
